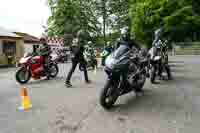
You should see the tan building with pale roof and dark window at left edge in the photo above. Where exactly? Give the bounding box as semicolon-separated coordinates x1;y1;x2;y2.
0;28;24;65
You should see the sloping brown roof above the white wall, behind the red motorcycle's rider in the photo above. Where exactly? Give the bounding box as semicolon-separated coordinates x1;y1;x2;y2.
14;32;40;43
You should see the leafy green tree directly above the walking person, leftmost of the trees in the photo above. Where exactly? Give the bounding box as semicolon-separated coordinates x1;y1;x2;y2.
48;0;100;45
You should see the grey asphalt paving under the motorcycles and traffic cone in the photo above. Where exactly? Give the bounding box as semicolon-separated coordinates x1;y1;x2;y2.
0;56;200;133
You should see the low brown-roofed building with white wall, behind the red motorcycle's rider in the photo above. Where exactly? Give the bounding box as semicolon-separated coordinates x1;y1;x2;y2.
15;32;41;53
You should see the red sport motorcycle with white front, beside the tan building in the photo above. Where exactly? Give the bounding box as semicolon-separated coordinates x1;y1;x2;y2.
16;55;59;84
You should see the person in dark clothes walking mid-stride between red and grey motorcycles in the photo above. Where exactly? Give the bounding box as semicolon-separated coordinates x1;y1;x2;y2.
65;30;90;87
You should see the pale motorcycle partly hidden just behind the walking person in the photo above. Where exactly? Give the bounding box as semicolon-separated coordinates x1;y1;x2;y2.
79;47;98;71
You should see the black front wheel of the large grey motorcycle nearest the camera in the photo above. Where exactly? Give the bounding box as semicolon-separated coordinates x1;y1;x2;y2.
100;80;119;109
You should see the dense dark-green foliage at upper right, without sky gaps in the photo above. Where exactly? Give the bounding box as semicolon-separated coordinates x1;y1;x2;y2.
129;0;200;45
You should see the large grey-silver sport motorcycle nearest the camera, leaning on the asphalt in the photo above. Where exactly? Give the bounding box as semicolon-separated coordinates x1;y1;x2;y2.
100;46;148;109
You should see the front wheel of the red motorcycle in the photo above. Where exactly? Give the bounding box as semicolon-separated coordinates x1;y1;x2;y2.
15;67;31;84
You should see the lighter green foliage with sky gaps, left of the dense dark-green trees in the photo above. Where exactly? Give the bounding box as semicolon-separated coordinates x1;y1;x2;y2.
48;0;129;45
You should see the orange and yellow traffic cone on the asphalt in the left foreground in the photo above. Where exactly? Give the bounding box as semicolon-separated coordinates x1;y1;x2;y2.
18;87;32;111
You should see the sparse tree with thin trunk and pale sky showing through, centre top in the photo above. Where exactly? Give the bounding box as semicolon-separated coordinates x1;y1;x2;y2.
95;0;129;44
